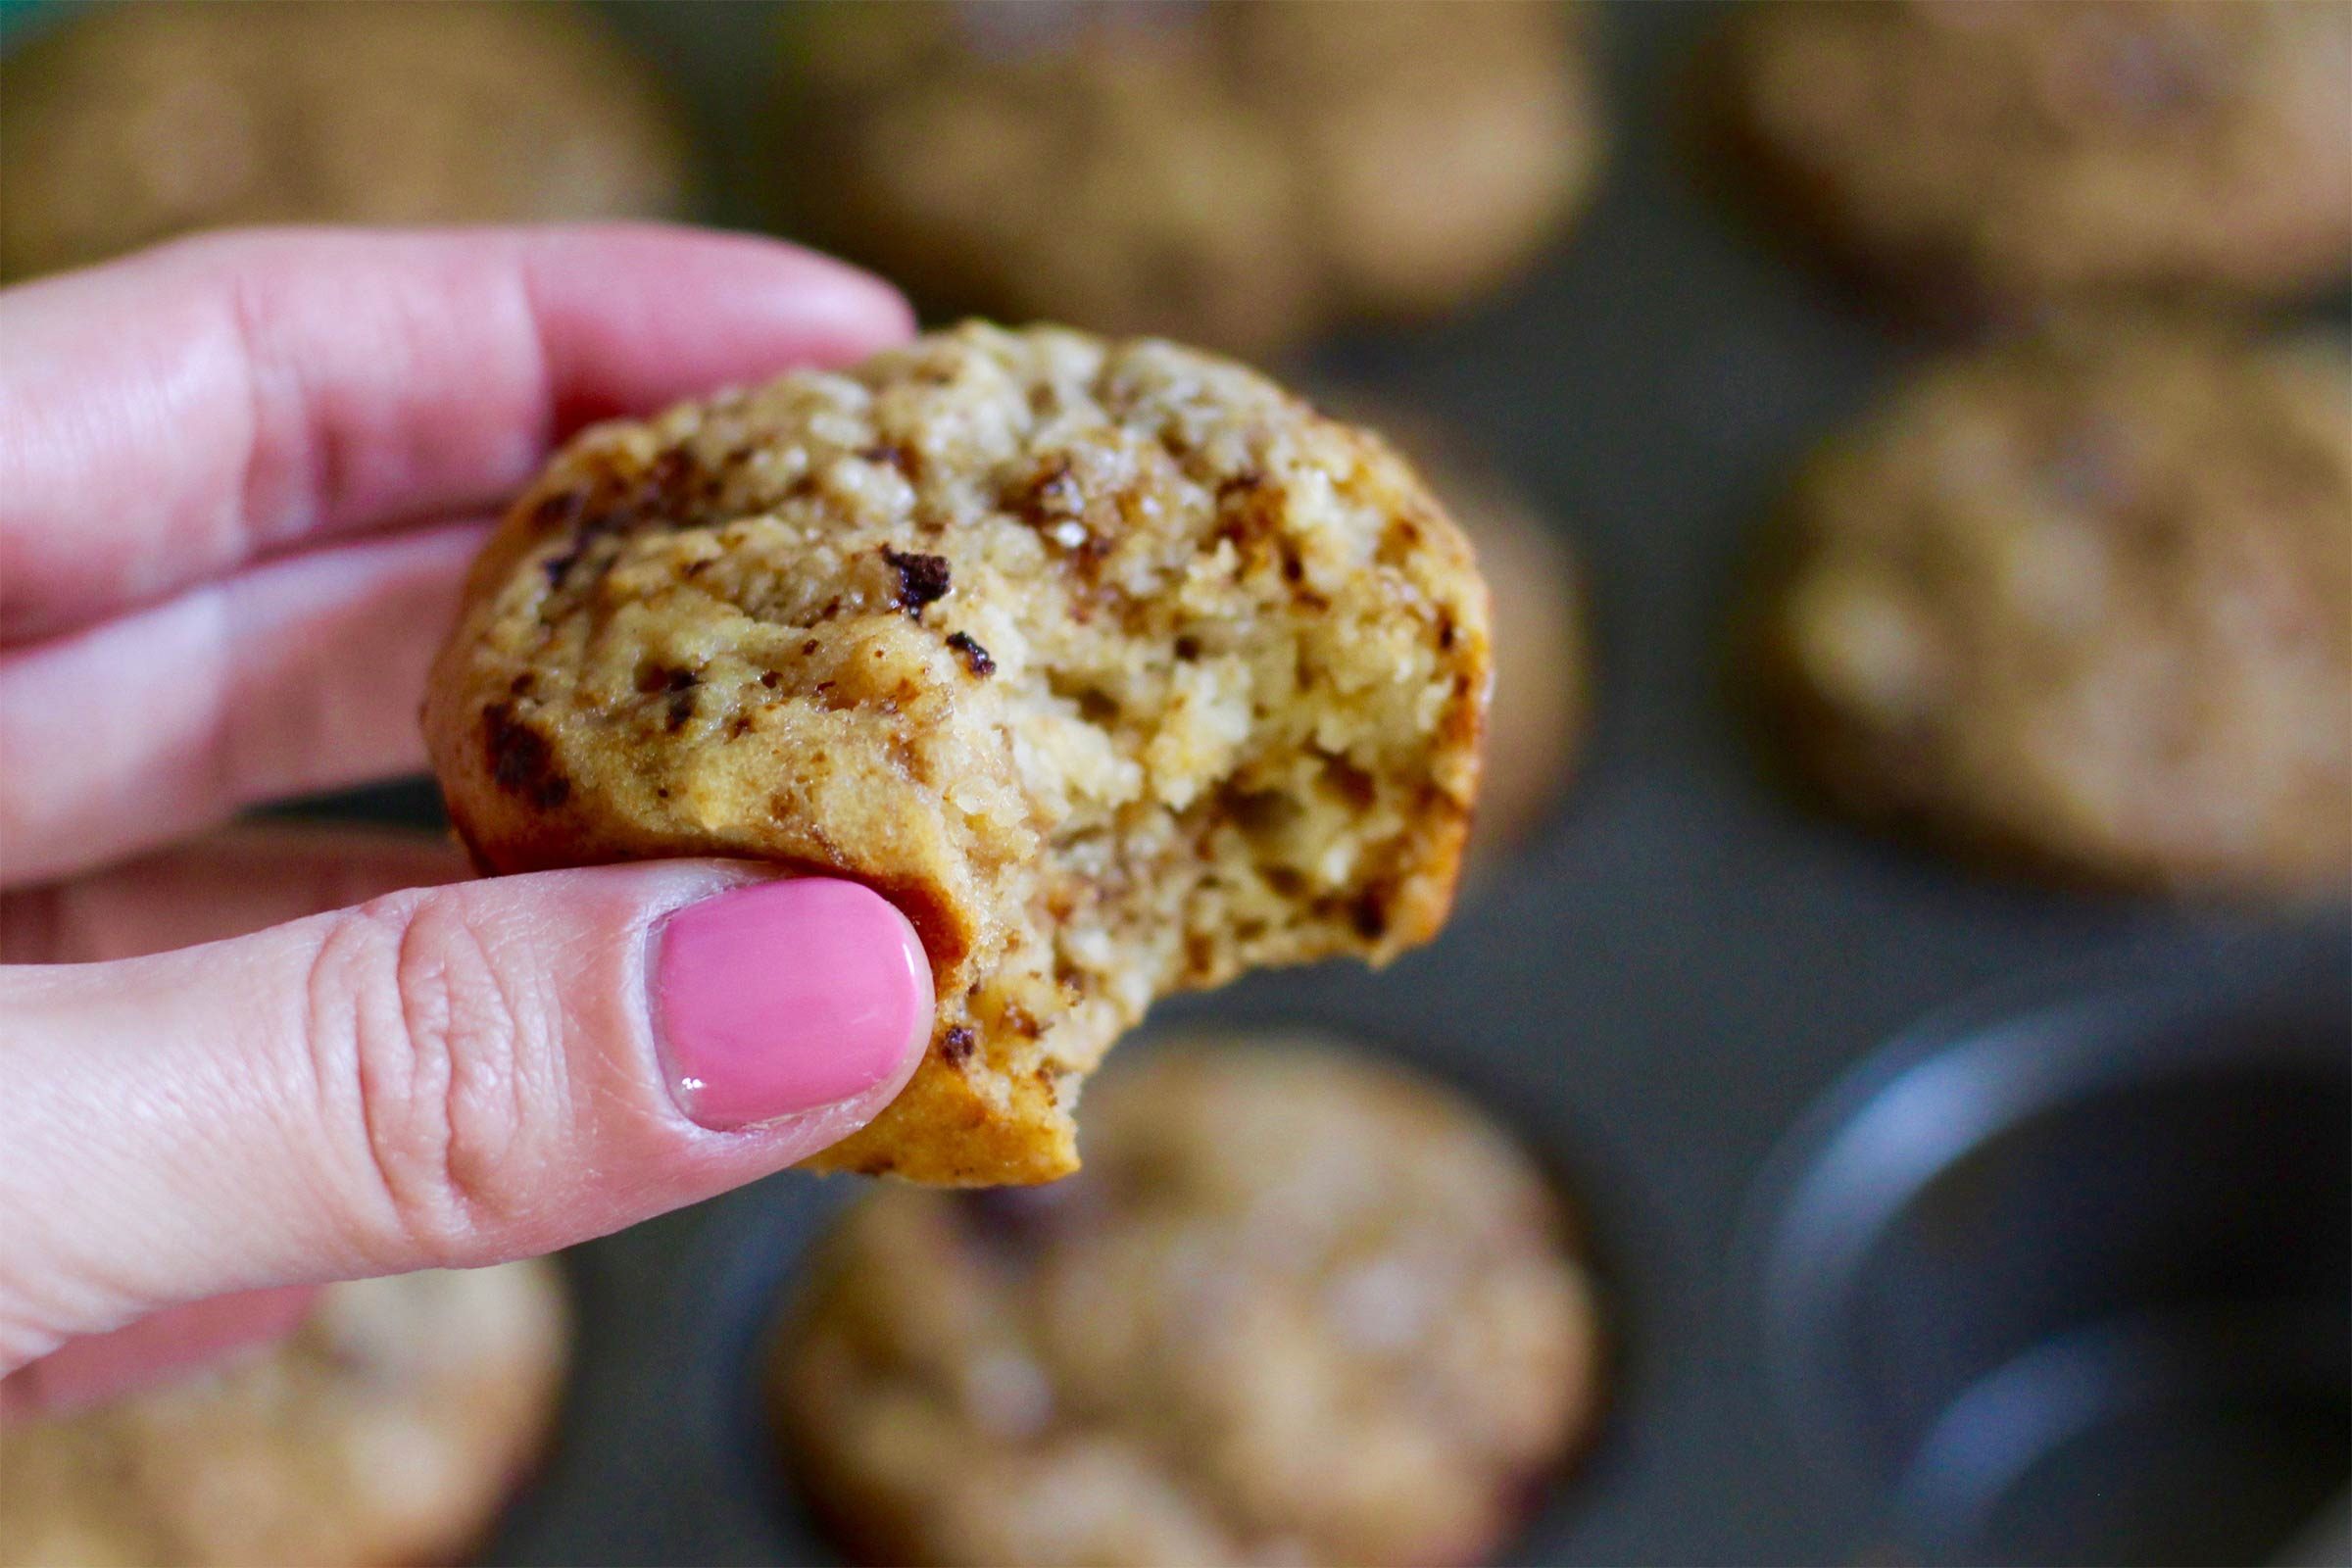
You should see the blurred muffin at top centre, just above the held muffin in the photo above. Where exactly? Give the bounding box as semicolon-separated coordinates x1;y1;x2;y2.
790;0;1599;353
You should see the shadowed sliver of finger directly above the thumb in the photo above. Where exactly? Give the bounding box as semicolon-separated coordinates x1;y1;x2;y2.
0;823;470;964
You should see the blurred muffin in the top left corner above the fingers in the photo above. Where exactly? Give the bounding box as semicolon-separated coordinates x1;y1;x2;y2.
0;0;687;277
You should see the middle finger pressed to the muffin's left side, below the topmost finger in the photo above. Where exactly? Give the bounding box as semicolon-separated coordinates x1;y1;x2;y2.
0;526;482;886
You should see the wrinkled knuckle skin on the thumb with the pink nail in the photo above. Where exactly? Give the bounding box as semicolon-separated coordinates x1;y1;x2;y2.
311;894;546;1262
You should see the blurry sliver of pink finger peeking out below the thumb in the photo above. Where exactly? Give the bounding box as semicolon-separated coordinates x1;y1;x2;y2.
0;1286;318;1420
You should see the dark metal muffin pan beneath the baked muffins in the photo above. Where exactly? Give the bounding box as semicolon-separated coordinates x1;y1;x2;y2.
9;2;2352;1563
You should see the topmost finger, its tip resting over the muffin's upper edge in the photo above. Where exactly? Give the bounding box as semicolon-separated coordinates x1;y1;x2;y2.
0;225;910;639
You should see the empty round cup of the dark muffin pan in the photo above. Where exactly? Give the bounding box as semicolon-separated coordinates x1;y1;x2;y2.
1754;943;2352;1563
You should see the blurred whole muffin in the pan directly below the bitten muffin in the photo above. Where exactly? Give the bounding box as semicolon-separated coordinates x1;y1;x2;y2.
769;1039;1601;1568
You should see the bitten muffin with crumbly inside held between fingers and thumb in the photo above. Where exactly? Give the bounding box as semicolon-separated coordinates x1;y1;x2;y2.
425;324;1489;1183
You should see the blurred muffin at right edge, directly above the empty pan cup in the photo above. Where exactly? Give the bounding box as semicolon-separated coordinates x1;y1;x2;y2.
1762;331;2352;894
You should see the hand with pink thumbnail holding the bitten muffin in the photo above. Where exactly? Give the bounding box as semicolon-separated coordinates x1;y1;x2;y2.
0;228;931;1408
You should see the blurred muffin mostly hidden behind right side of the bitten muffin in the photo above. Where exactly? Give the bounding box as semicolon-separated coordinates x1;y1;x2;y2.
1315;388;1592;870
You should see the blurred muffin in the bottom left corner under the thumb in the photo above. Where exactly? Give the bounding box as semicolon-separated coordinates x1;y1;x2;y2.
0;1262;566;1568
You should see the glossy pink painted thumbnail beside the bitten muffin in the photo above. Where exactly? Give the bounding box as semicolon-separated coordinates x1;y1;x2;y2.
654;877;931;1128
